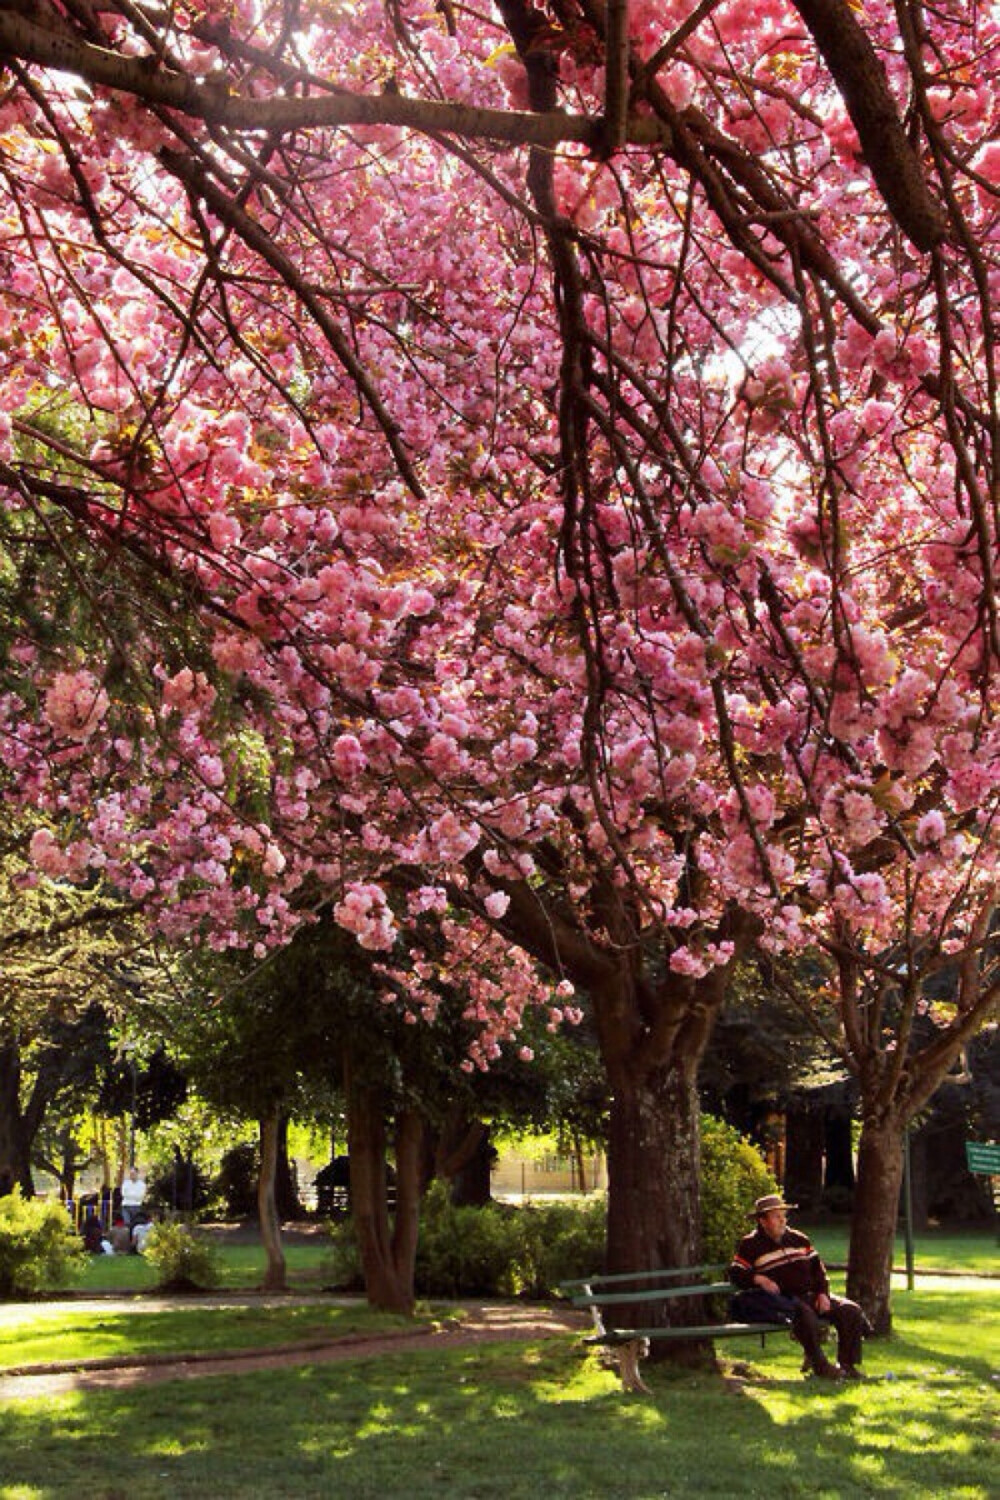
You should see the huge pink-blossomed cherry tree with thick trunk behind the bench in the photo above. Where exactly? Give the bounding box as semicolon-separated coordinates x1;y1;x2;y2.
0;0;1000;1338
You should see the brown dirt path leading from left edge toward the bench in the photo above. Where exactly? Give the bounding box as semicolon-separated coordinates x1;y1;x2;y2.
0;1304;588;1406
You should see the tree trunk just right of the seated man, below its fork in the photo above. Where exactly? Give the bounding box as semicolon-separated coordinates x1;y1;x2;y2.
847;1115;906;1334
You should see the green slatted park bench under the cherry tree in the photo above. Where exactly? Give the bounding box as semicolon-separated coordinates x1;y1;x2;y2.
559;1265;789;1391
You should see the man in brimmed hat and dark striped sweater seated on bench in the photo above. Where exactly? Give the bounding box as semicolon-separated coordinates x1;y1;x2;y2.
729;1193;867;1380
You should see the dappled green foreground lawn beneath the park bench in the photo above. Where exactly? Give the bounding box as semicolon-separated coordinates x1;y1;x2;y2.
0;1287;1000;1500
